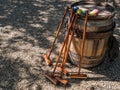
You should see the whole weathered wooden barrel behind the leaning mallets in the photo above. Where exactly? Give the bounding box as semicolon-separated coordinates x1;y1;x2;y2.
69;1;115;68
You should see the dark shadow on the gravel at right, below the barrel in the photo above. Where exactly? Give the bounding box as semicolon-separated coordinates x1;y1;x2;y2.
88;53;120;82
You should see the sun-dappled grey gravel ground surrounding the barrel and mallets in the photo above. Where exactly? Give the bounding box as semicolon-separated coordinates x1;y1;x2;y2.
0;0;120;90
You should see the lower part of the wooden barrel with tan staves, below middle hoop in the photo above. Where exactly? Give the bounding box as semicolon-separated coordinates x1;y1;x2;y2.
69;27;112;68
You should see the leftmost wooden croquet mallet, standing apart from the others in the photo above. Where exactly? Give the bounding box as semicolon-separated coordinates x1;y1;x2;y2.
43;7;69;65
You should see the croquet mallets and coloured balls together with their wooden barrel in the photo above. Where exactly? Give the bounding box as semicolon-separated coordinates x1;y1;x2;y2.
43;1;118;85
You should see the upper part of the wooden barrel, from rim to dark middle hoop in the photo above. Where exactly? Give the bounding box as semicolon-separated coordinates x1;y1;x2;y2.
71;1;115;32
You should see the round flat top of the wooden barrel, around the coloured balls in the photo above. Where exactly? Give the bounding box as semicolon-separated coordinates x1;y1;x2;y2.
71;1;115;20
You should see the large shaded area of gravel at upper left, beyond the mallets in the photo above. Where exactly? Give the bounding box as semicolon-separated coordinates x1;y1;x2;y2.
0;0;71;49
